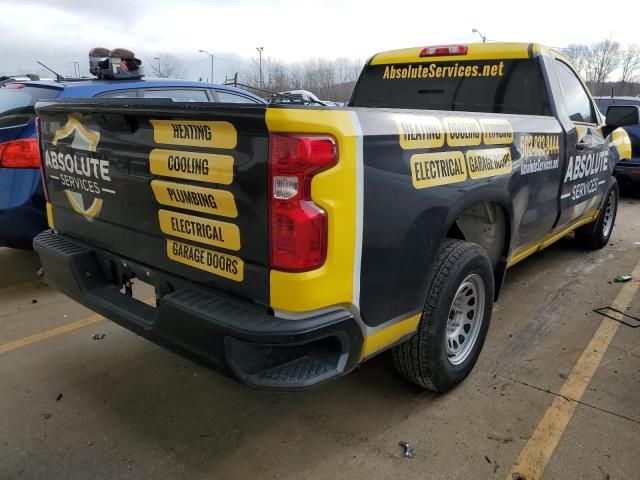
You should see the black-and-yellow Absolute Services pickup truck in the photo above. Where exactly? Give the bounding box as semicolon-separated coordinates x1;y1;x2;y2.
34;43;630;391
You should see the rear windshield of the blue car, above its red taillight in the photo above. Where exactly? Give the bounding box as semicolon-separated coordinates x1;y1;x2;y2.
0;84;60;128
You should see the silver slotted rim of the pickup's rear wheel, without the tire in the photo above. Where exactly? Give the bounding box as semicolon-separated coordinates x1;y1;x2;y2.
445;273;485;365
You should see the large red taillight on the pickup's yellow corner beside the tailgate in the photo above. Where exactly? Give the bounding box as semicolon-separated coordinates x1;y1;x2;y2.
269;134;338;272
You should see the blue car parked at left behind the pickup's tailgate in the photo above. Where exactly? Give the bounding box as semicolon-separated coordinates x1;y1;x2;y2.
0;79;265;249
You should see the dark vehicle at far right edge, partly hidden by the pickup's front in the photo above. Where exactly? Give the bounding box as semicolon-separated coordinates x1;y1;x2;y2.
595;97;640;194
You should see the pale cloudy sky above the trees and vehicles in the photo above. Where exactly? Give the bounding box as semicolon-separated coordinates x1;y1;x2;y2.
0;0;640;82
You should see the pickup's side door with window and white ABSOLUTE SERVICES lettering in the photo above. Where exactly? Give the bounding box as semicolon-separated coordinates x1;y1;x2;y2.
554;58;612;229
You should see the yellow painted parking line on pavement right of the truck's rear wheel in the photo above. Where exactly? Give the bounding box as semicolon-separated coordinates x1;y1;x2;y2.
506;263;640;480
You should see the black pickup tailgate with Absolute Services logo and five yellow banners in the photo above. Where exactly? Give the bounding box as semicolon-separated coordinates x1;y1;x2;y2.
38;99;269;304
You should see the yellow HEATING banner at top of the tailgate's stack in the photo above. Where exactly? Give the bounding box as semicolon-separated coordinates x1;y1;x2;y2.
150;120;238;149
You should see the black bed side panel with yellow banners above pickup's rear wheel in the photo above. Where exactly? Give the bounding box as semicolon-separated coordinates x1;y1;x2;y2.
358;110;565;326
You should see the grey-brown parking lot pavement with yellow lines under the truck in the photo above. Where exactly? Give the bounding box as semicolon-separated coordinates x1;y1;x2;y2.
0;198;640;480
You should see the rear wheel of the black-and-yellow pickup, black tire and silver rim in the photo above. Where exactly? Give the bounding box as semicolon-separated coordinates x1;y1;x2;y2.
393;239;494;392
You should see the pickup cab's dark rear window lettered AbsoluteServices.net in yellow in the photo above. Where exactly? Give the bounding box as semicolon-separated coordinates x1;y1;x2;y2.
352;60;551;116
